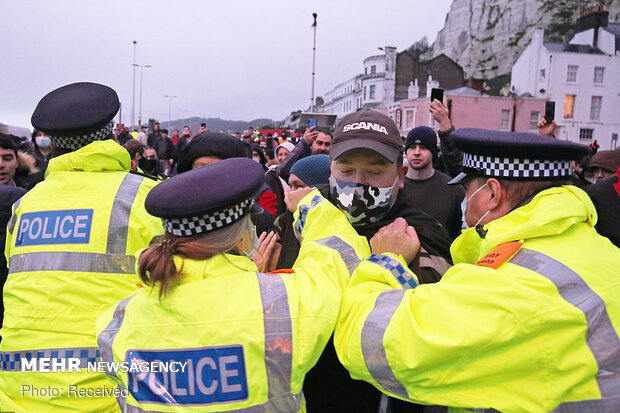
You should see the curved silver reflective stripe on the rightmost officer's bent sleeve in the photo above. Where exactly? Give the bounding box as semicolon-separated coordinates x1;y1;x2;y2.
362;289;409;398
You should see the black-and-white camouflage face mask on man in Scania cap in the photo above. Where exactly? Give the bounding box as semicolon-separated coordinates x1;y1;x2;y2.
329;177;398;225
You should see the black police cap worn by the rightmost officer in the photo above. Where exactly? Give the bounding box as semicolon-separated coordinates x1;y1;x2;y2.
449;128;588;184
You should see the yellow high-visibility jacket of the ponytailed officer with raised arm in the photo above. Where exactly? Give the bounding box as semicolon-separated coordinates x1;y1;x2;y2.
97;191;370;412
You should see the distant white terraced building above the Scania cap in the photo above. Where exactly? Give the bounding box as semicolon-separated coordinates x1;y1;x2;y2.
318;46;397;118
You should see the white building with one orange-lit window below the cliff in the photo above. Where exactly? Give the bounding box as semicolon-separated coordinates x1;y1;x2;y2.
511;12;620;149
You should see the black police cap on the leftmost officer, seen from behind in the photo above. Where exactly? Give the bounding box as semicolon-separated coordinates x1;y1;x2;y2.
31;82;120;149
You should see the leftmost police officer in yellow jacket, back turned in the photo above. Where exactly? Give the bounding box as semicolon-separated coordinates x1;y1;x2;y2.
0;83;163;413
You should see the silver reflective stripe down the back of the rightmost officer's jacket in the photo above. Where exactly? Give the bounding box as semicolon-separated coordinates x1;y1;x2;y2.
510;248;620;402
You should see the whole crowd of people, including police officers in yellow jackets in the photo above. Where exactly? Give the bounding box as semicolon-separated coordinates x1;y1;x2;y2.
0;83;620;413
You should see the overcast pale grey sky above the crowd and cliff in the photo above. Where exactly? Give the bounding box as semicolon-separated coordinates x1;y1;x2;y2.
0;0;451;128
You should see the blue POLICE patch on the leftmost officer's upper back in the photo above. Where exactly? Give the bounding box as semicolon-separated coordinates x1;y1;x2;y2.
15;209;93;247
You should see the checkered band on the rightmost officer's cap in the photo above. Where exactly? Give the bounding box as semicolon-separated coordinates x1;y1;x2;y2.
463;153;573;179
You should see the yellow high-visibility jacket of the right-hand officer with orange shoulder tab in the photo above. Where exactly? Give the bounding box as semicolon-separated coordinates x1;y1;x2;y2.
335;186;620;412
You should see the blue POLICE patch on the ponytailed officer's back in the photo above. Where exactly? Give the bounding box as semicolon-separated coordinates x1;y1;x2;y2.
125;345;248;406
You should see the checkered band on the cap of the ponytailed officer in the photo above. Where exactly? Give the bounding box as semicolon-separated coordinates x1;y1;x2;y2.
162;198;254;237
